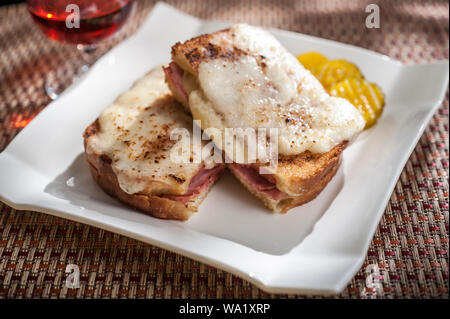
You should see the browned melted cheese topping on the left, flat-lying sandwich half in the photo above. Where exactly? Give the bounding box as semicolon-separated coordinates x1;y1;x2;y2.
86;67;202;195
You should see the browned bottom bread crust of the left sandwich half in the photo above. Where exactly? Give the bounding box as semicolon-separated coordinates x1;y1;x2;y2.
83;120;209;221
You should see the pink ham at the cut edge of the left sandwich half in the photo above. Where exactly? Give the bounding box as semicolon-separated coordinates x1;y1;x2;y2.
163;165;224;204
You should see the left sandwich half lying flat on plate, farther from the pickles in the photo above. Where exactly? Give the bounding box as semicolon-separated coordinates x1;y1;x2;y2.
84;67;224;220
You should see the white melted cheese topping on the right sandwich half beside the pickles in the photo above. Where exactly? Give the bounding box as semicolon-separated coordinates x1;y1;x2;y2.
193;24;365;155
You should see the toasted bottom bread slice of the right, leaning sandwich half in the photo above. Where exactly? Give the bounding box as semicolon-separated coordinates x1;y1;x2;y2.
228;146;341;213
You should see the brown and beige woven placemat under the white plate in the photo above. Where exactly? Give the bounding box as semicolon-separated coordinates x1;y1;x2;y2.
0;0;449;298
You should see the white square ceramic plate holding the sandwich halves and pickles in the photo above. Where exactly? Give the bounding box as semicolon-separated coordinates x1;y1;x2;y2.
0;4;448;294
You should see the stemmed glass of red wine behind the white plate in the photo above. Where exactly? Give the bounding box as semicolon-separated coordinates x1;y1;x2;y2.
27;0;134;100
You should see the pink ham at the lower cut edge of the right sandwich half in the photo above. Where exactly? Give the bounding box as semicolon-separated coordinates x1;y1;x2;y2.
229;163;288;200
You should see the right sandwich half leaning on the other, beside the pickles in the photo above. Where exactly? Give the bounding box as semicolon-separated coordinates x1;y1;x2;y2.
165;24;365;212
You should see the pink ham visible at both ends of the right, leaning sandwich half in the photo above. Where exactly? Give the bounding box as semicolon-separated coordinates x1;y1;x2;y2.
164;62;287;200
